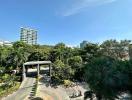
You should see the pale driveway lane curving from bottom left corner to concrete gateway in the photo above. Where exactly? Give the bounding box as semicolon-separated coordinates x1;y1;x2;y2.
2;70;35;100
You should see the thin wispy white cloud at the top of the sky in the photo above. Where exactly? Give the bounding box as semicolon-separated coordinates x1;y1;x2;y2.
62;0;117;16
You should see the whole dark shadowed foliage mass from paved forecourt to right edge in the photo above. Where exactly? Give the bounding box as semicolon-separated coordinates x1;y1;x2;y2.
85;56;132;100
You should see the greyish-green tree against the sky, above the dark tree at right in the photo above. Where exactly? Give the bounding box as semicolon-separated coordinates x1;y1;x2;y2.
101;40;131;60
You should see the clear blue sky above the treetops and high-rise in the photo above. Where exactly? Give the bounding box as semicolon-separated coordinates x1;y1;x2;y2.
0;0;132;46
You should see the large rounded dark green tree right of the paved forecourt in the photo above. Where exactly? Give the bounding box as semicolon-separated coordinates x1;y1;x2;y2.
85;56;119;100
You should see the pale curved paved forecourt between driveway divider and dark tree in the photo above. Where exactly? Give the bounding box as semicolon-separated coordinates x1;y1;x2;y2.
37;76;86;100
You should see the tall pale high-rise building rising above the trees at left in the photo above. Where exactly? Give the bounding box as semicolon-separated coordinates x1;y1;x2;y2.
20;28;37;45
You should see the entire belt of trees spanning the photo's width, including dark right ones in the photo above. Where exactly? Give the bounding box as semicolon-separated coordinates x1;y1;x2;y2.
0;40;132;100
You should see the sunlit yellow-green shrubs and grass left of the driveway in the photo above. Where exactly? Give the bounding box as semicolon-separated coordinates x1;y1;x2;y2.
0;67;21;98
